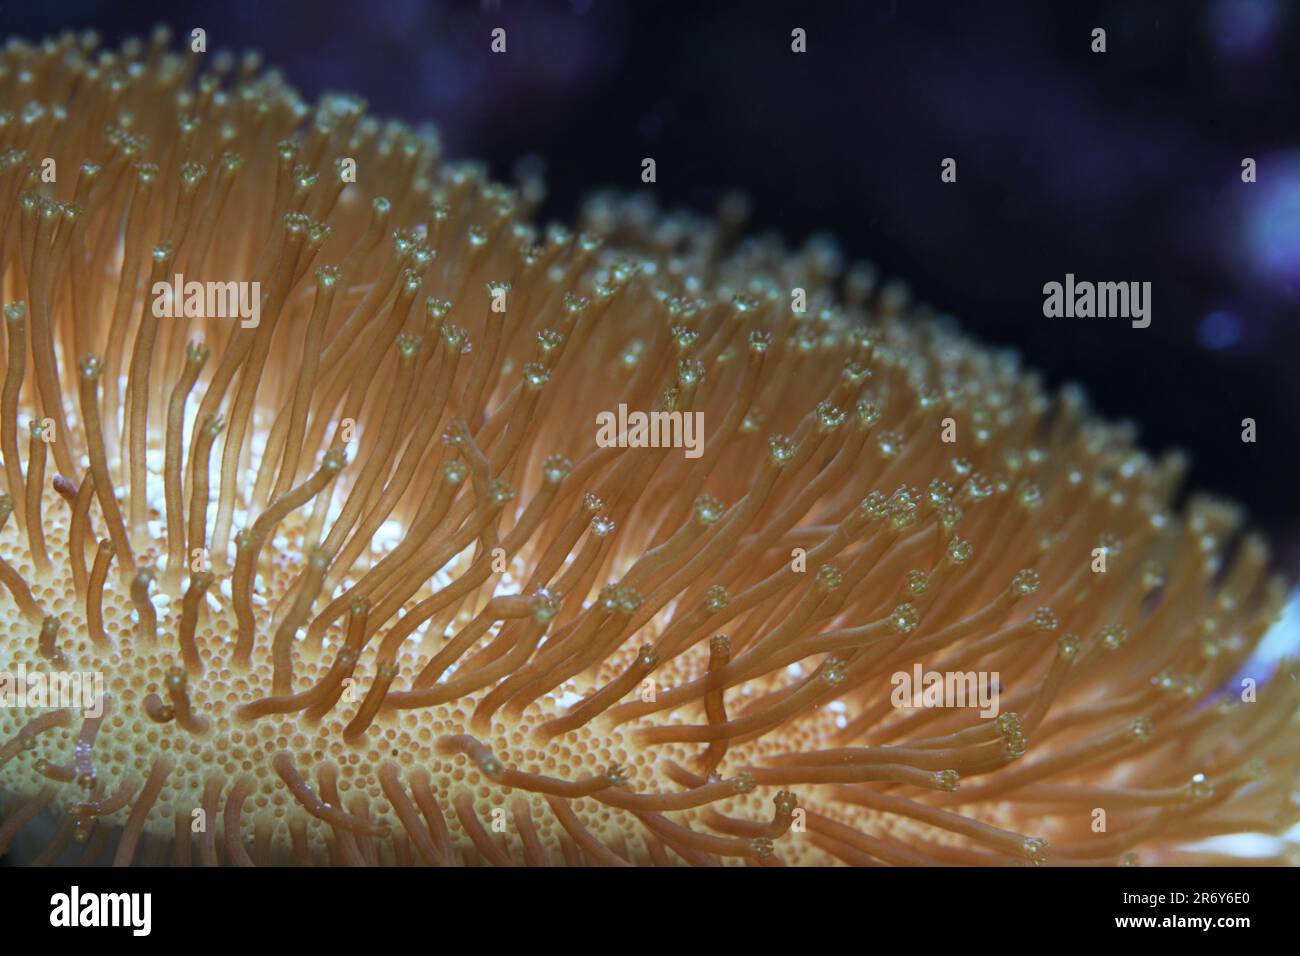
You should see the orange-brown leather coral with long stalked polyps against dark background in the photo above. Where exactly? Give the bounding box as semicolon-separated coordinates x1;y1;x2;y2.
0;31;1300;868
